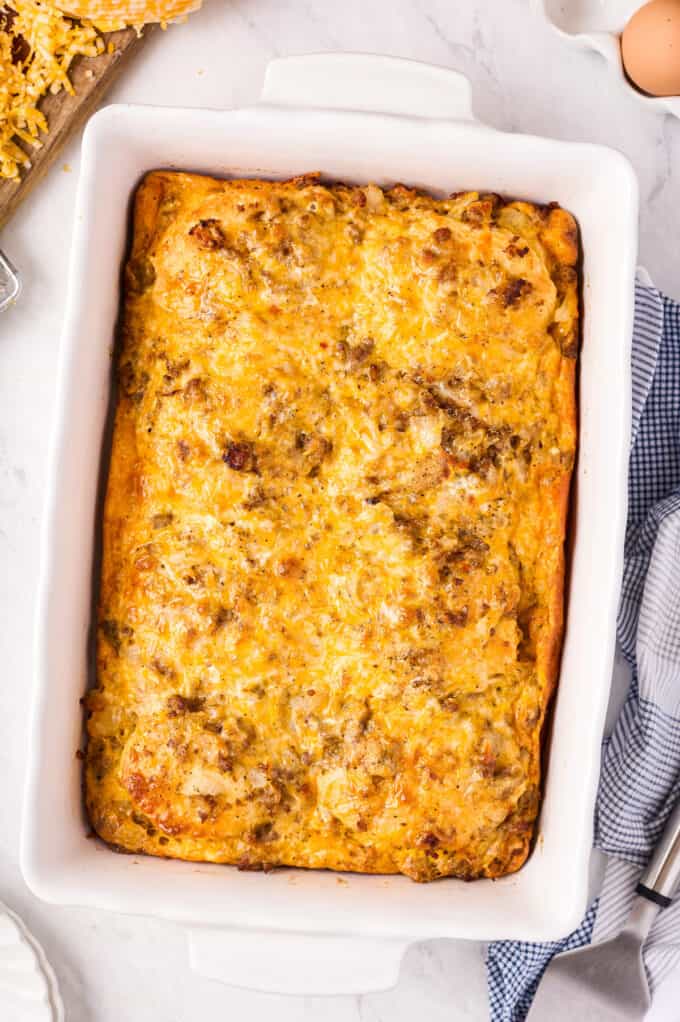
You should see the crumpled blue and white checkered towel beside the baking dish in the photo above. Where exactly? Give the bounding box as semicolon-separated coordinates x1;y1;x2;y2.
487;281;680;1022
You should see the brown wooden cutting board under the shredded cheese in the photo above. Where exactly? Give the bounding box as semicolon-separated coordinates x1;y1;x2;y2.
0;26;153;228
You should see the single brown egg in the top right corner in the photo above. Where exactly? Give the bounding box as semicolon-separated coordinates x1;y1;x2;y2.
621;0;680;96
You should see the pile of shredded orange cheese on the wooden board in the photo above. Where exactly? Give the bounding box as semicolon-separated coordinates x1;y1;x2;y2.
0;0;103;179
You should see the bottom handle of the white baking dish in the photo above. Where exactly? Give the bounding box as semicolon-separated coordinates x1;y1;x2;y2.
188;927;409;996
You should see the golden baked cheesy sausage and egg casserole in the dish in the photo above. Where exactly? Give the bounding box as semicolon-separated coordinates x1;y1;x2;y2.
86;172;579;881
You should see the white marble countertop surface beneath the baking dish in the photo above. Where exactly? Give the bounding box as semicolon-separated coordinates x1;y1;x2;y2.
0;0;680;1022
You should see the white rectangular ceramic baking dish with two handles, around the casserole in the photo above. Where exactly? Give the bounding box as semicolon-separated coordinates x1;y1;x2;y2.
21;54;637;992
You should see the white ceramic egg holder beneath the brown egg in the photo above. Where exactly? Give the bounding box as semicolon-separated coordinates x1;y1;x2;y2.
532;0;680;118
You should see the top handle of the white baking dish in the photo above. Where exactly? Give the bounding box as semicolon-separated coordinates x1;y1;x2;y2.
262;53;474;122
